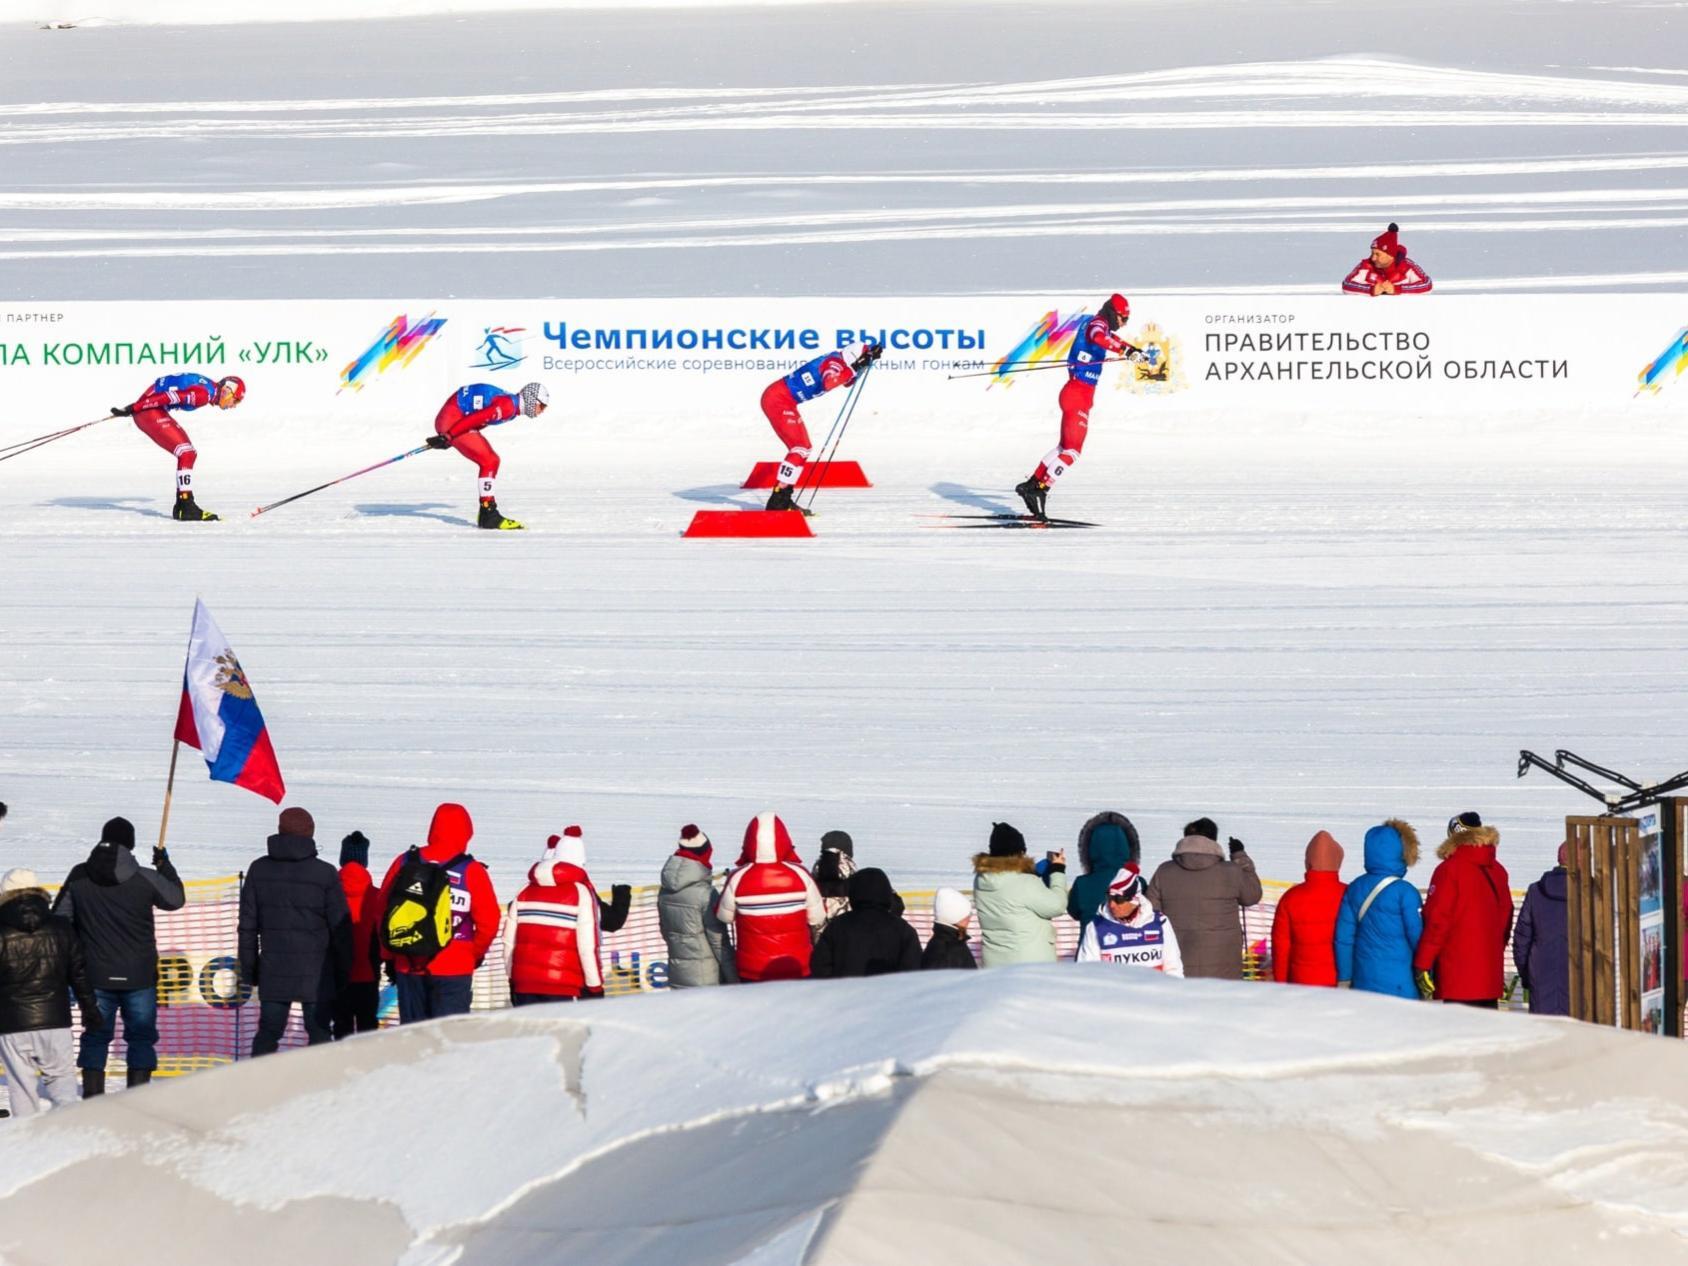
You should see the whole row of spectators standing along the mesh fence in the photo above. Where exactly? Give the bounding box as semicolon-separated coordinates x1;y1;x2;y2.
0;803;1570;1116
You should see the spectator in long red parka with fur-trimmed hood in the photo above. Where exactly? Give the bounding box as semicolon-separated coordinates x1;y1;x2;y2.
1413;814;1512;1009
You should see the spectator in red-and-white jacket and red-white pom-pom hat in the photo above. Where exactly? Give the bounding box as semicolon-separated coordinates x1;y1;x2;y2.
505;827;604;1006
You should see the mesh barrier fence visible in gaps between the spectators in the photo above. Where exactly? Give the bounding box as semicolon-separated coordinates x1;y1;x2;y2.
3;876;1523;1107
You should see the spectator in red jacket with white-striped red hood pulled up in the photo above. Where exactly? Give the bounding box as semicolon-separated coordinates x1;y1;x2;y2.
719;812;827;982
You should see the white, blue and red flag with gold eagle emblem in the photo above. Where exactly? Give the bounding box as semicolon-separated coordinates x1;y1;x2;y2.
176;603;287;803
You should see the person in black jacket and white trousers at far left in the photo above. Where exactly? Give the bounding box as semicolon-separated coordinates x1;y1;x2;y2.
0;869;100;1117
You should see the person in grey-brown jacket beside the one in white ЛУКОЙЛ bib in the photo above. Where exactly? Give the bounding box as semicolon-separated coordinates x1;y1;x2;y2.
1148;817;1263;981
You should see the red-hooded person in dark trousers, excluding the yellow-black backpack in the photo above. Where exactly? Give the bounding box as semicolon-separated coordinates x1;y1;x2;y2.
375;803;500;1025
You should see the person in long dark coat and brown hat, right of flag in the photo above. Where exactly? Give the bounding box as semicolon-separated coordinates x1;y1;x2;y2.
240;809;351;1057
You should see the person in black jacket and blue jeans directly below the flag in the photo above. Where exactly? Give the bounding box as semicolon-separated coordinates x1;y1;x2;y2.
52;817;187;1099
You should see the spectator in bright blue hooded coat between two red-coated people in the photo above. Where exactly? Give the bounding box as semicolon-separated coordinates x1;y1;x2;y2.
1337;819;1425;998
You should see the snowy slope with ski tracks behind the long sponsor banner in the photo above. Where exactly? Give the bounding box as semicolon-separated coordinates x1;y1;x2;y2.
0;0;1688;300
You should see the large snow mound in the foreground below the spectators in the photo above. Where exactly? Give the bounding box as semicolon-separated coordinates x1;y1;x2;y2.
0;966;1688;1266
